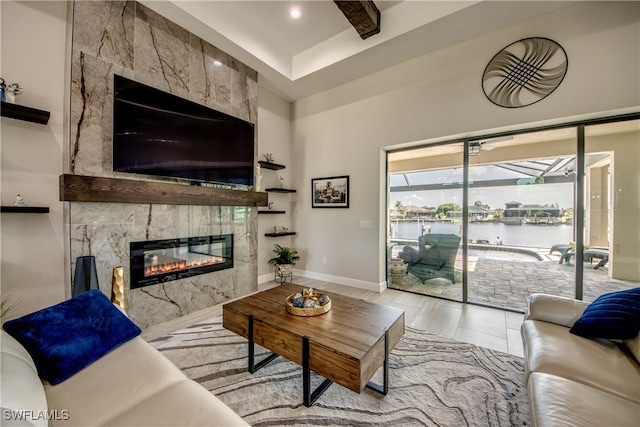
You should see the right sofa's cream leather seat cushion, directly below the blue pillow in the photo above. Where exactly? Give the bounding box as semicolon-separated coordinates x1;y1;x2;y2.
522;320;640;403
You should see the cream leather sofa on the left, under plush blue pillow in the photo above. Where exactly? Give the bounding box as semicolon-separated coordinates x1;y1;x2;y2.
0;290;248;427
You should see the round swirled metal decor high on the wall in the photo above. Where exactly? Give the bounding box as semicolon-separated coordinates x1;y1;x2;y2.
482;37;569;108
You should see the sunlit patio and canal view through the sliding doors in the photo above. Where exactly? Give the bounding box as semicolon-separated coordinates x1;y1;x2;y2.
388;121;640;311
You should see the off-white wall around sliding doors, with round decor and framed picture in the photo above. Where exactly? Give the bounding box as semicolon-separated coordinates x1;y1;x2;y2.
291;2;640;289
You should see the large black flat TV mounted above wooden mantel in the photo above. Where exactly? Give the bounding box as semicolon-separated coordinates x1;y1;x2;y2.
113;75;254;185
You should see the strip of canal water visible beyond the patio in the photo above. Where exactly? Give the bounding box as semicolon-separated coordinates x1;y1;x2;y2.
391;221;573;248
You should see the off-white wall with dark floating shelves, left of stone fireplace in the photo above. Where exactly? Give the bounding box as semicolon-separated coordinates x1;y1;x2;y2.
0;1;67;316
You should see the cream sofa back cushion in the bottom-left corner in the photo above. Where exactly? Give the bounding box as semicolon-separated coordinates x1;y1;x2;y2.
0;331;48;427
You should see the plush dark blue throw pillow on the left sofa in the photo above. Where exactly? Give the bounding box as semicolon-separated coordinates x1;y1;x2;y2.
3;289;141;384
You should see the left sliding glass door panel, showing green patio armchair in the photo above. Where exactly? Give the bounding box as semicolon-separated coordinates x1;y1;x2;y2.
388;142;464;301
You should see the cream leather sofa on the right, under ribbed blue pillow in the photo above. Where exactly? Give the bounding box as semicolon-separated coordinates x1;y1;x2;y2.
521;294;640;427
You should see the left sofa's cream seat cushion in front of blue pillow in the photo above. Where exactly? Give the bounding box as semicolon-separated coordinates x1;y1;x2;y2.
45;337;247;427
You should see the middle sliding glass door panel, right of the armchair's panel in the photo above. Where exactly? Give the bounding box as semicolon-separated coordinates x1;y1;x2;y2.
467;129;576;310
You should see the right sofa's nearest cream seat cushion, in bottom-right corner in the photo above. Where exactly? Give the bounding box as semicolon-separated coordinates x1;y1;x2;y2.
527;372;640;427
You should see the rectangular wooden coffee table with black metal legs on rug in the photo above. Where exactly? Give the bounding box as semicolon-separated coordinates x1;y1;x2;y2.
222;283;404;407
